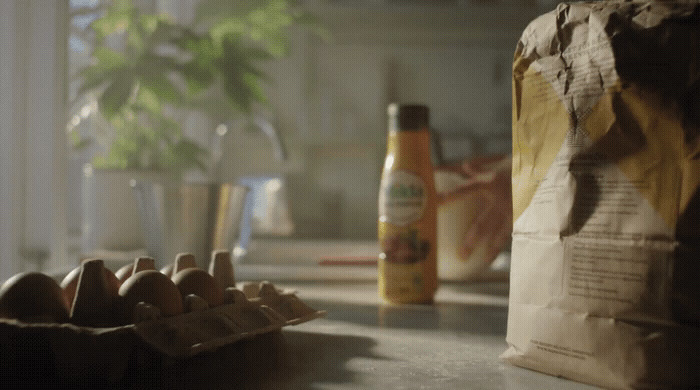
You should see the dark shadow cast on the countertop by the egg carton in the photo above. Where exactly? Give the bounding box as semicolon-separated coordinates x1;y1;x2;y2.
130;331;383;390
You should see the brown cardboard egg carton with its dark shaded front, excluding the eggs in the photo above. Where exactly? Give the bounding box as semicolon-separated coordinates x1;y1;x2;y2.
0;282;326;383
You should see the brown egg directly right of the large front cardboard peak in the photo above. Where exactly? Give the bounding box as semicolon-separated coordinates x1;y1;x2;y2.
119;270;184;323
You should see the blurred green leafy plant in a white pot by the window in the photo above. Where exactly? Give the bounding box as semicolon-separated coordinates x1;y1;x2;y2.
69;0;323;258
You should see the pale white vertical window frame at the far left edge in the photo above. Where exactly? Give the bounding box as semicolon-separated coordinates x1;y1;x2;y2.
0;0;70;280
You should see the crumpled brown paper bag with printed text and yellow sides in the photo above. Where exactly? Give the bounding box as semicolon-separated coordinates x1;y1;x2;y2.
502;1;700;389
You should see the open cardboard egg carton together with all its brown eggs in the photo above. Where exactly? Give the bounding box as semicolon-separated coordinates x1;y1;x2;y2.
0;251;325;378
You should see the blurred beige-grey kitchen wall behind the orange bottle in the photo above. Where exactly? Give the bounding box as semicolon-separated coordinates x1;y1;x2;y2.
217;0;538;238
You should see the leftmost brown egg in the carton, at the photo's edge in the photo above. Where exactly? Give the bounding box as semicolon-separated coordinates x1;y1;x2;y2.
0;272;69;323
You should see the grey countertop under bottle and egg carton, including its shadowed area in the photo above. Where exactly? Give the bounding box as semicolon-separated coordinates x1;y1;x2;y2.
12;280;608;390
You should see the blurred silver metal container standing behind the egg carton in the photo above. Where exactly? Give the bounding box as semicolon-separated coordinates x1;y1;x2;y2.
131;181;248;269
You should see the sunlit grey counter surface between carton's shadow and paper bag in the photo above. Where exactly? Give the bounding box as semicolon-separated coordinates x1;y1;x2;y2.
238;282;594;390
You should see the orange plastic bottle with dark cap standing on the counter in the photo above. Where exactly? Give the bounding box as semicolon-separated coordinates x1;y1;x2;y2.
378;104;437;303
